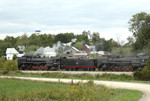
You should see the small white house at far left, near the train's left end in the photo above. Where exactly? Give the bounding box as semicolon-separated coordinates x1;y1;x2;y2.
6;48;19;60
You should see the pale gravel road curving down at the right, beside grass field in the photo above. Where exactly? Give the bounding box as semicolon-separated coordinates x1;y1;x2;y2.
0;76;150;101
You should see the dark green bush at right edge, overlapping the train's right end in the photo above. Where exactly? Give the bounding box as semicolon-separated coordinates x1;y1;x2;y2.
133;60;150;80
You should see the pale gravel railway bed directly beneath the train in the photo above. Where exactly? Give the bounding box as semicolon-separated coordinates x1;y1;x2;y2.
21;71;133;75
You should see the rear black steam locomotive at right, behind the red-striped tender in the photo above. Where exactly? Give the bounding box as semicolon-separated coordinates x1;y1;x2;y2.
97;55;149;71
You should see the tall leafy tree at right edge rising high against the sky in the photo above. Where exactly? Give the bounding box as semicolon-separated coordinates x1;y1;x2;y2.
129;12;150;50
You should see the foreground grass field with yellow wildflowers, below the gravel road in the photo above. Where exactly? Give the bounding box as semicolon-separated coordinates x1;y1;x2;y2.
0;79;142;101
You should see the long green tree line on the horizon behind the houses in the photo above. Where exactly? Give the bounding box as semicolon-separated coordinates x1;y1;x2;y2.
0;31;118;56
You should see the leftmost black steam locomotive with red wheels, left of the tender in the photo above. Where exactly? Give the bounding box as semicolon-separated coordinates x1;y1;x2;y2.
18;56;59;70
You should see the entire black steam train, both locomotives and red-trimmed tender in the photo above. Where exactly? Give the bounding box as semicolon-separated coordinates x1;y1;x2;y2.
18;55;150;71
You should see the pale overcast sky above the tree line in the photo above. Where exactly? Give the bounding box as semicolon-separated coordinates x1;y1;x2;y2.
0;0;150;40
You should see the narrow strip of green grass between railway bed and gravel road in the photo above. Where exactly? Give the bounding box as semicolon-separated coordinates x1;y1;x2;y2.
0;71;150;83
